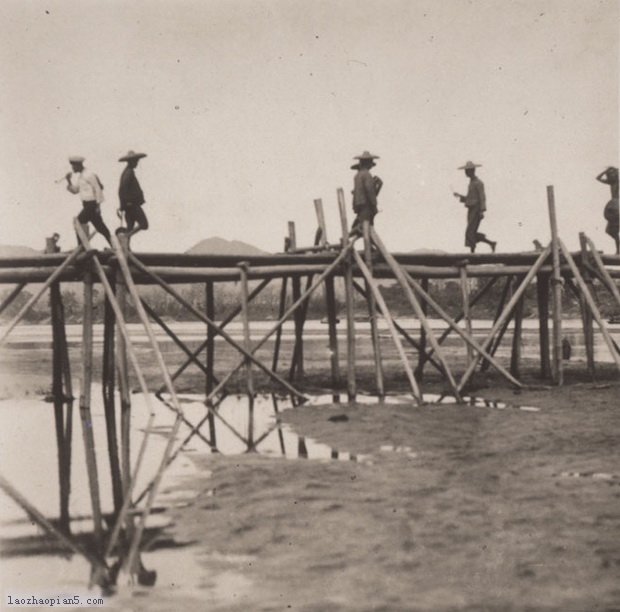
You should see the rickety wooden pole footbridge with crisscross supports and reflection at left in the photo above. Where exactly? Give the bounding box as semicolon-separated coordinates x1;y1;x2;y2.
0;188;620;584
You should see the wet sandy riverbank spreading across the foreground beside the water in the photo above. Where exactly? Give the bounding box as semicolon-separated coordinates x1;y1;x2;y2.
4;338;620;612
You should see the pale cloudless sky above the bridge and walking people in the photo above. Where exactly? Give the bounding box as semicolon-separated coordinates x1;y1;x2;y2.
0;0;620;252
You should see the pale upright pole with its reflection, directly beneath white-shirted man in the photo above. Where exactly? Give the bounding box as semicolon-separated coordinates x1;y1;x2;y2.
80;270;103;549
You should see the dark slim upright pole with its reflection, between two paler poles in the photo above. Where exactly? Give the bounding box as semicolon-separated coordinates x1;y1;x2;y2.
102;280;123;516
